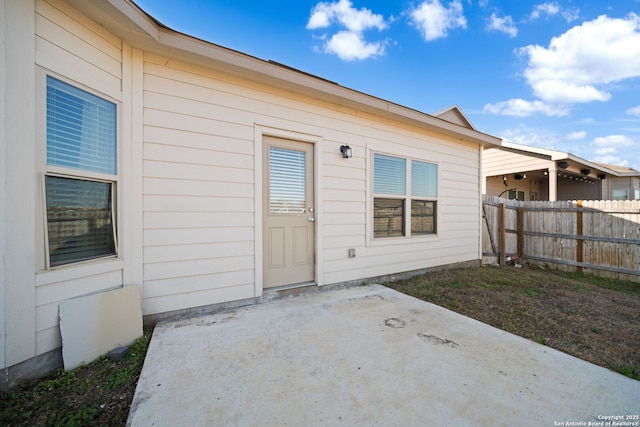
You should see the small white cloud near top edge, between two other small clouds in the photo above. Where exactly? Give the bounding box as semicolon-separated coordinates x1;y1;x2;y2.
410;0;467;41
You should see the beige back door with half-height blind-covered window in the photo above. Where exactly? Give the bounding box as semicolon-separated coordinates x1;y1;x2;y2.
262;136;315;288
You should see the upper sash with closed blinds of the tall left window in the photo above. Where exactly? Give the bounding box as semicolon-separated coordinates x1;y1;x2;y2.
47;76;117;175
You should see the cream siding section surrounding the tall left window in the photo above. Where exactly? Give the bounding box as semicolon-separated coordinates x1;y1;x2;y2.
28;0;125;356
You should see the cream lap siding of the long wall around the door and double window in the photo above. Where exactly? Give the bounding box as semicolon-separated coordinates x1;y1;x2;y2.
143;54;480;314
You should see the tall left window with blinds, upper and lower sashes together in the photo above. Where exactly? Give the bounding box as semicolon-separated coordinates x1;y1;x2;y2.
45;77;117;267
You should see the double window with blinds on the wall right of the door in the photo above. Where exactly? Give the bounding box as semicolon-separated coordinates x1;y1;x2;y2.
373;153;438;238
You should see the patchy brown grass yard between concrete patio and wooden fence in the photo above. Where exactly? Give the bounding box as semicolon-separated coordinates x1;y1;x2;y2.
385;266;640;380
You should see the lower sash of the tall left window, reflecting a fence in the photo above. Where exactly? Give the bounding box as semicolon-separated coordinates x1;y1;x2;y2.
45;176;115;266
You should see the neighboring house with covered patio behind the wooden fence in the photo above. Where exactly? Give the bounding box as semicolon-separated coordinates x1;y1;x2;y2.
482;141;640;201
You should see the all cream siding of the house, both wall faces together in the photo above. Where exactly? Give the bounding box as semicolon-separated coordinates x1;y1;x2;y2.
0;0;496;376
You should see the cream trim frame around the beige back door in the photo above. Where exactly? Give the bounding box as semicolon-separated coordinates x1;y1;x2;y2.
254;124;324;297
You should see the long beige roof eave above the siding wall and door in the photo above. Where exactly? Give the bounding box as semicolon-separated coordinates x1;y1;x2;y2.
67;0;502;147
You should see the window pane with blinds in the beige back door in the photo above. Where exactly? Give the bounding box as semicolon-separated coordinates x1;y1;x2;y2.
269;147;307;214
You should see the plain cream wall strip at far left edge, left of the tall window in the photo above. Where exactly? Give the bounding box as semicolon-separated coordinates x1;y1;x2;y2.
0;0;36;367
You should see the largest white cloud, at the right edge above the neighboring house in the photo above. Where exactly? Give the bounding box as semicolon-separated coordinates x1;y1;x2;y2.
517;13;640;104
